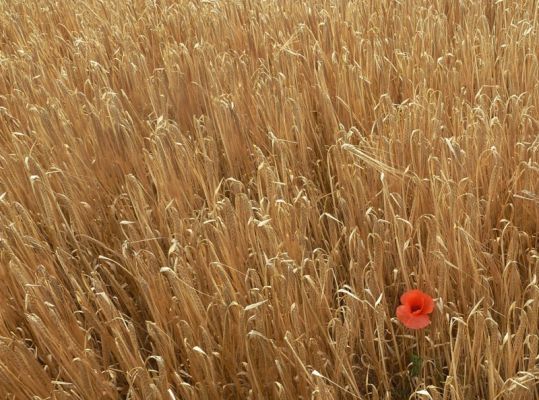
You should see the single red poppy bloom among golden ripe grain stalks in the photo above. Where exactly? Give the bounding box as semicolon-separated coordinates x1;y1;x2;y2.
397;289;434;329
